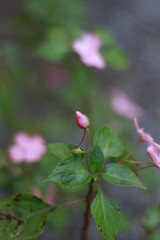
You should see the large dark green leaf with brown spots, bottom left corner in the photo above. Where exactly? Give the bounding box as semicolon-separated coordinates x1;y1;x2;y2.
0;194;50;240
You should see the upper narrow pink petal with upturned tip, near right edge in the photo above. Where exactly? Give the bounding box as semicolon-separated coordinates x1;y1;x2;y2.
134;118;154;145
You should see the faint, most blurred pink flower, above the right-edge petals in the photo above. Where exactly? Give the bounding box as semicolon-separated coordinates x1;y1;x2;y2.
110;89;144;119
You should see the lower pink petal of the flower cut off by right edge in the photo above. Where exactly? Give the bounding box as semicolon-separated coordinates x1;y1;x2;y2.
147;144;160;168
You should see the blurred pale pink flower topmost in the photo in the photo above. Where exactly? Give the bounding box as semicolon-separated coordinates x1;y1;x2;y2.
73;33;106;69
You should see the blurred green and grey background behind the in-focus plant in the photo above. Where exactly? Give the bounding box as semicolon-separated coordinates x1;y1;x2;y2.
0;0;160;240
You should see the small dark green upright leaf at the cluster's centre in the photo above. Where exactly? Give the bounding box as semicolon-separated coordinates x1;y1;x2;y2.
89;145;104;172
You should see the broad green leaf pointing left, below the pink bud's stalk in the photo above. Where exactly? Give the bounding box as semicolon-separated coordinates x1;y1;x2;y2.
45;155;91;188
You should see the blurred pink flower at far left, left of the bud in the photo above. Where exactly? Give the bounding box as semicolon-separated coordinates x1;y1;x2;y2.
8;132;47;163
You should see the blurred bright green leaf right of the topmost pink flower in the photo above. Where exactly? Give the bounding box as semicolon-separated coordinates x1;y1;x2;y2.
103;47;129;70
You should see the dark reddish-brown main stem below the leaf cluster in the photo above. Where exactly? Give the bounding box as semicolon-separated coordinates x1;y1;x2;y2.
81;178;94;240
